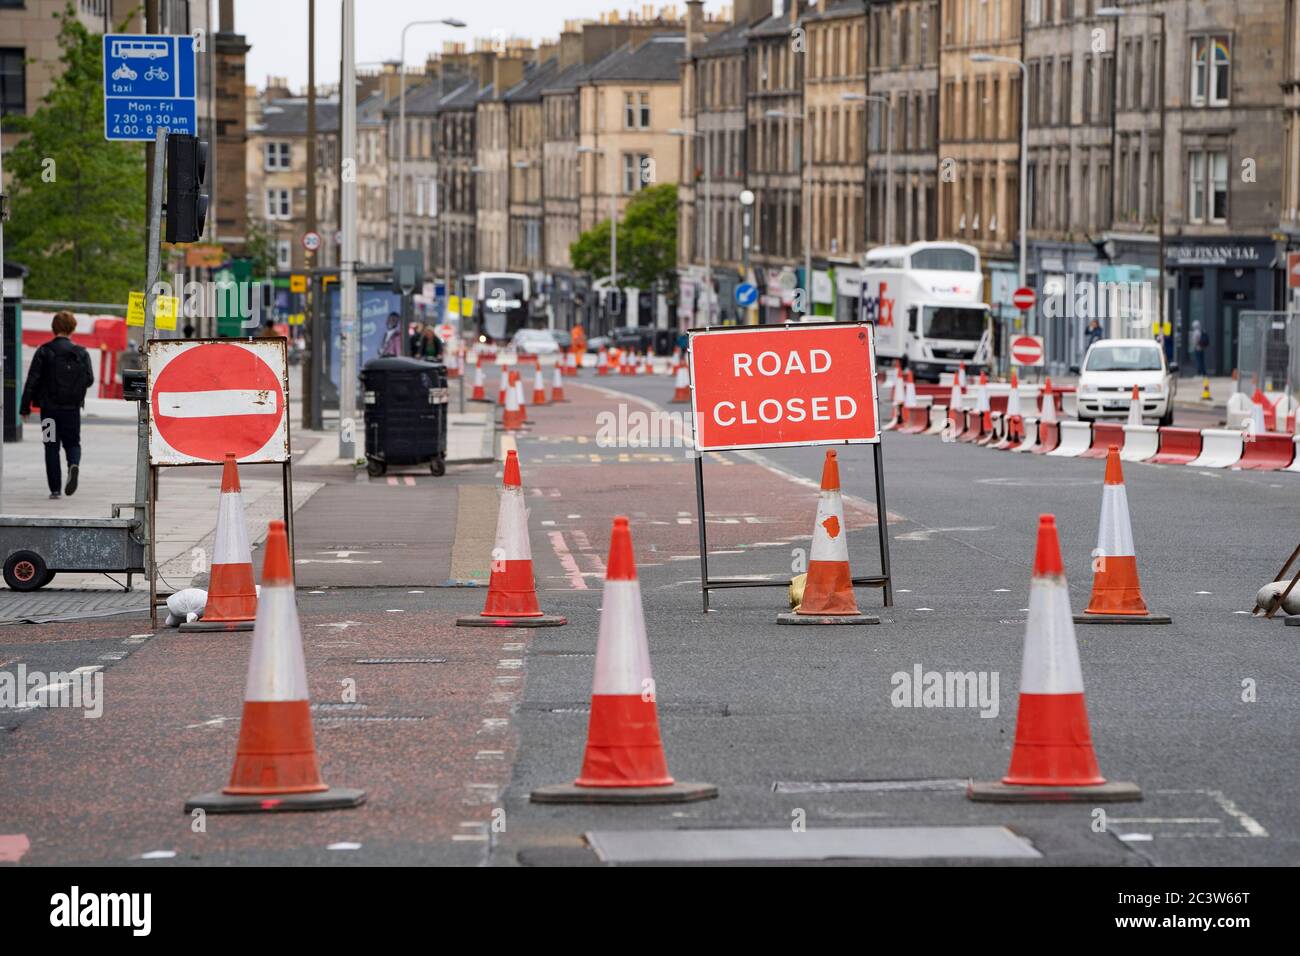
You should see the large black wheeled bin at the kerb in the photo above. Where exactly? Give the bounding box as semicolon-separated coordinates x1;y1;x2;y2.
361;356;447;475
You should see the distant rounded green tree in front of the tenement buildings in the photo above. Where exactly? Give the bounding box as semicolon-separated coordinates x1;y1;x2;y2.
569;182;677;289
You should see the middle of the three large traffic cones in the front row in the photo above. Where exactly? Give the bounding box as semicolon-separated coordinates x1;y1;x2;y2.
530;516;718;804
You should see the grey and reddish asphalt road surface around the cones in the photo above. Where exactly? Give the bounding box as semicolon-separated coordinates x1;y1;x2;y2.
0;373;1300;866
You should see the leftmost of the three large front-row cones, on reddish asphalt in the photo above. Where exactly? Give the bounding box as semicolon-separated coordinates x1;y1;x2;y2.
185;522;365;813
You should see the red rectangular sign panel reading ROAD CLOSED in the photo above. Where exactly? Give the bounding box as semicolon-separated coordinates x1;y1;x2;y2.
690;324;880;451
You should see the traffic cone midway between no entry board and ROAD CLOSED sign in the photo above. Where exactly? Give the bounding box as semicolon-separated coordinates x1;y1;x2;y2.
456;450;567;627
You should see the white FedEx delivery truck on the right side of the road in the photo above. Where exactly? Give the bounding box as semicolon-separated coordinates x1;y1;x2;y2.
859;242;993;381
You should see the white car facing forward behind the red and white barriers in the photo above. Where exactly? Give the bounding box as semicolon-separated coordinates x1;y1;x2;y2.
1070;338;1178;425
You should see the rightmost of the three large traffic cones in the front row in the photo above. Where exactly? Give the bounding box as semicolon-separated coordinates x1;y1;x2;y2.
966;515;1141;803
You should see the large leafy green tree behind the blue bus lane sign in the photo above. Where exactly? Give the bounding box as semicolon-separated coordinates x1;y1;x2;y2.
5;3;146;302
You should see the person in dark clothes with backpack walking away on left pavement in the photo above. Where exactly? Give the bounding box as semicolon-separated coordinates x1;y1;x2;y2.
18;312;95;498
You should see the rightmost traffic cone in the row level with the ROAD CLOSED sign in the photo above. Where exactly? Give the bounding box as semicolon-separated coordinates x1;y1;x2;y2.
1075;445;1170;624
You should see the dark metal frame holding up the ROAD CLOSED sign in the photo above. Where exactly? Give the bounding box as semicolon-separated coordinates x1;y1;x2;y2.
688;321;893;614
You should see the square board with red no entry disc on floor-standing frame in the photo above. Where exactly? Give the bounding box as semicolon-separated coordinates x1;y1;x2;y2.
148;338;289;464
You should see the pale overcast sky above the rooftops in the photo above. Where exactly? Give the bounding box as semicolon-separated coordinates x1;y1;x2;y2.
233;0;731;91
